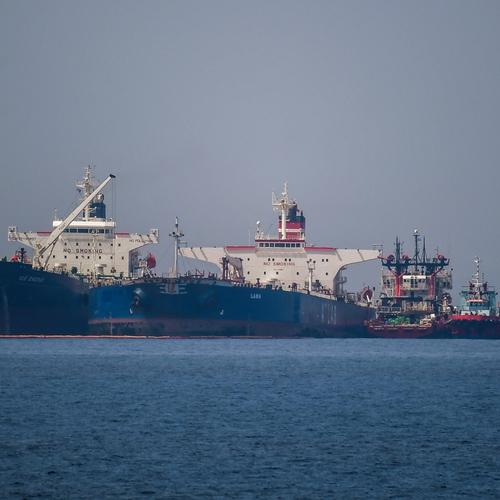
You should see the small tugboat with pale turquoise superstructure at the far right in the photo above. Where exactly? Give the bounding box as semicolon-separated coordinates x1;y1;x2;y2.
448;257;500;339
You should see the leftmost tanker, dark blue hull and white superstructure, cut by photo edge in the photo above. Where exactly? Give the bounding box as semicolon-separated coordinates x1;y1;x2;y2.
0;167;158;336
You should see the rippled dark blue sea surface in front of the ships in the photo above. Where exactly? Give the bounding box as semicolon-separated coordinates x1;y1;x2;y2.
0;338;500;499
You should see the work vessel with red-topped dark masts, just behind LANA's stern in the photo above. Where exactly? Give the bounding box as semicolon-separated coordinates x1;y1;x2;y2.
365;229;452;338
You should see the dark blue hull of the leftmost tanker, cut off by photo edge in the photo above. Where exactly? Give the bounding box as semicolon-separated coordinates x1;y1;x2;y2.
0;261;89;336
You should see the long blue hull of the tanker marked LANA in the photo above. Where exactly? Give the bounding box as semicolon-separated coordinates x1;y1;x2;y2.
89;278;374;338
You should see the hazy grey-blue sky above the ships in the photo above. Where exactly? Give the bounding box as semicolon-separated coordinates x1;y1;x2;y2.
0;0;500;302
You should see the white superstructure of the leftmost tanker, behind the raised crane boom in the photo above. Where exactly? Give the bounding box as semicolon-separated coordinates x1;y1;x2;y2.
8;166;159;278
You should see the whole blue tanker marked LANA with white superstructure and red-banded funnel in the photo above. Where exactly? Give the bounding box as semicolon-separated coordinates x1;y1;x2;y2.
89;184;379;337
